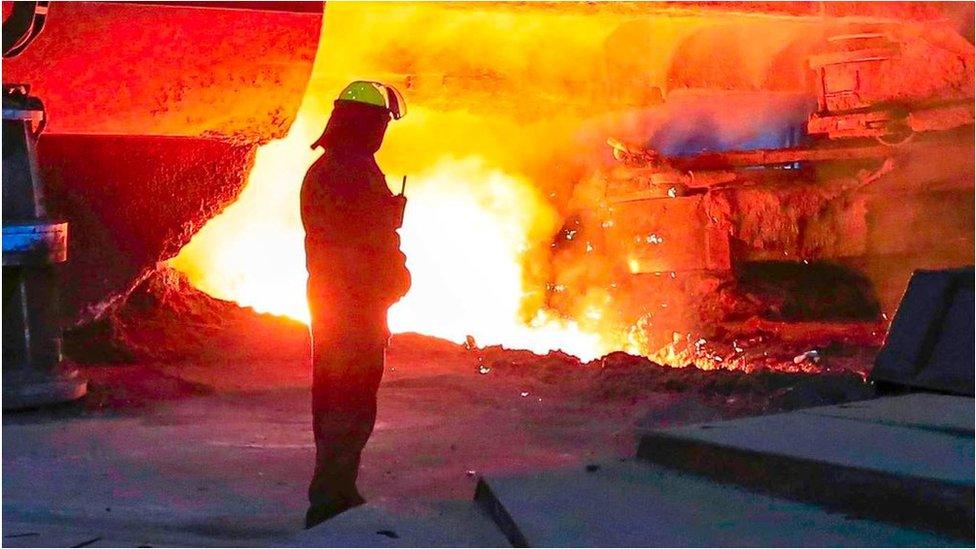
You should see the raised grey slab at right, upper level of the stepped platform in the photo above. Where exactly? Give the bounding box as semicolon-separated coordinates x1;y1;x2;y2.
638;395;976;542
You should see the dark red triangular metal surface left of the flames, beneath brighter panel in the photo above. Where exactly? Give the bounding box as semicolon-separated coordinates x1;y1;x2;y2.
38;134;256;326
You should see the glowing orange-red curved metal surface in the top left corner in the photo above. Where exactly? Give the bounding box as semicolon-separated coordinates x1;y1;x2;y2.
3;2;322;143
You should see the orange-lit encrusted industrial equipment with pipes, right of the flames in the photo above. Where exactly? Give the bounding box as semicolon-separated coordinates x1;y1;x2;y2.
584;29;973;348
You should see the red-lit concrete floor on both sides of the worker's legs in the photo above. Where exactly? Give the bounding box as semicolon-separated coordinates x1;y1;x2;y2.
3;356;722;546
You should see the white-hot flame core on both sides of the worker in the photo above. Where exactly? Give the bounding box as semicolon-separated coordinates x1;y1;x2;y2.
172;112;608;360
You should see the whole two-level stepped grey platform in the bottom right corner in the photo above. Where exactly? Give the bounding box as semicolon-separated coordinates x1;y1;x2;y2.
475;394;976;547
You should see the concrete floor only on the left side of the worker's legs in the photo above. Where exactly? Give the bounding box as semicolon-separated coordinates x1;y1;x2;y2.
3;390;313;545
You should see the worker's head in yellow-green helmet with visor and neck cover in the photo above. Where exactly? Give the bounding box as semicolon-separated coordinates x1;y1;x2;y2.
312;80;407;154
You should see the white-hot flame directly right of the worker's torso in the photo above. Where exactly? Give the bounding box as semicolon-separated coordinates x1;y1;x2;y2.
389;158;601;359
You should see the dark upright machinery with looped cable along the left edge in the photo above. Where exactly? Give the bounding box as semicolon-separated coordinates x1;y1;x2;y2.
3;2;87;409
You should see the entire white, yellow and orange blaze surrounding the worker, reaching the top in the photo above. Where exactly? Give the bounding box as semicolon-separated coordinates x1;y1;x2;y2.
172;2;932;367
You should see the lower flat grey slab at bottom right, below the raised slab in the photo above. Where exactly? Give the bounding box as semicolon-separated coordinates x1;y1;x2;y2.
476;460;967;547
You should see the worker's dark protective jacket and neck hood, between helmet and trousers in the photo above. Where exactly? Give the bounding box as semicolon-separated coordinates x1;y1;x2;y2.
301;101;410;309
